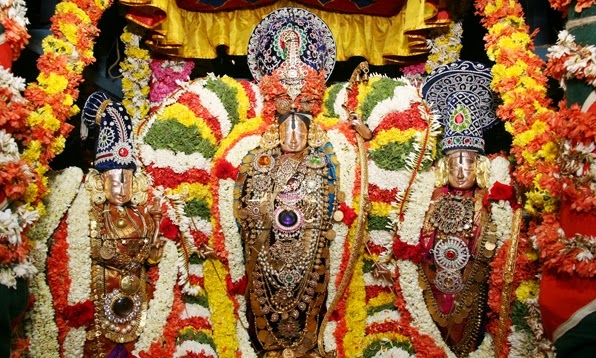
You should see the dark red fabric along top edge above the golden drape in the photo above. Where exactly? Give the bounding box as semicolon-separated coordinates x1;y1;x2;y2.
176;0;405;17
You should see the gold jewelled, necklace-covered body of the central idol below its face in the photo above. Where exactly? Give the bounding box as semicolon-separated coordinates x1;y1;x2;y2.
243;148;337;349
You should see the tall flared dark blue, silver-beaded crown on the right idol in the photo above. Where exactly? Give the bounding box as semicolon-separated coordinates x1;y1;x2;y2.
422;61;498;153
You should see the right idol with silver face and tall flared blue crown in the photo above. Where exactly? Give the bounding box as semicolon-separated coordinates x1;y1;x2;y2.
419;61;497;356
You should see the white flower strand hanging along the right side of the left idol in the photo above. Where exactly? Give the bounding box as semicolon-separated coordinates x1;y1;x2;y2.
132;238;178;356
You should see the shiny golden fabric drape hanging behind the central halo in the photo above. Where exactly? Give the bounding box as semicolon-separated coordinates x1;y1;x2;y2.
120;0;449;65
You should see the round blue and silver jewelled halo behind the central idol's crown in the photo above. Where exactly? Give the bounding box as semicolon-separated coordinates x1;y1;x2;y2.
247;7;336;81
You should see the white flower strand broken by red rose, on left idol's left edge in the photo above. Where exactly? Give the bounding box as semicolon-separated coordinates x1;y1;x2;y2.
64;188;92;357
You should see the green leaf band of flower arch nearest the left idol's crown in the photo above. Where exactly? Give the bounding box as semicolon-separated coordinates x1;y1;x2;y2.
145;118;216;158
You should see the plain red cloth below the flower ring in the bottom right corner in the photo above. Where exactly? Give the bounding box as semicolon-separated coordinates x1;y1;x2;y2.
538;271;596;339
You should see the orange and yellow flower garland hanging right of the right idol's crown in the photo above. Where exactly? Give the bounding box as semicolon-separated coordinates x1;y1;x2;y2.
475;0;557;215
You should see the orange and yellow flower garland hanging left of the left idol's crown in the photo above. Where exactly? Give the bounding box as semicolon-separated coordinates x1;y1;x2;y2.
22;0;112;204
